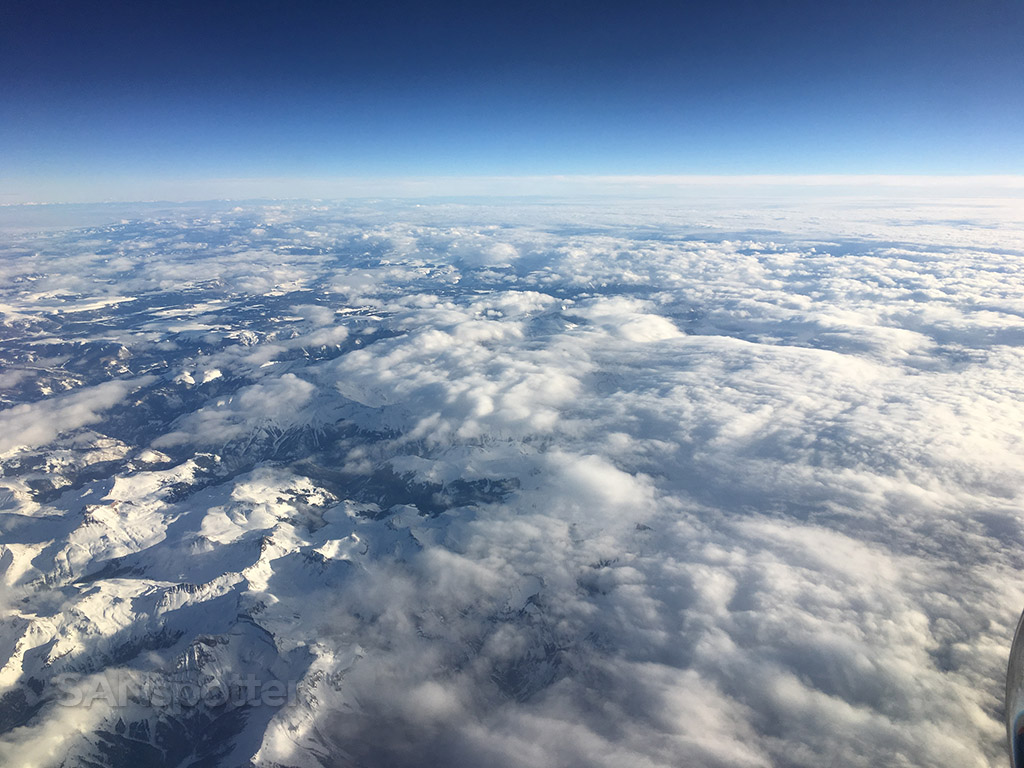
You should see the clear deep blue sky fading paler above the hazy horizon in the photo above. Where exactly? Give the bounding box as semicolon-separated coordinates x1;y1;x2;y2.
0;0;1024;202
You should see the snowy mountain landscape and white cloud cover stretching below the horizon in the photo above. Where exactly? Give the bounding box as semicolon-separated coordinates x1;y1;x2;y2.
0;201;1024;768
